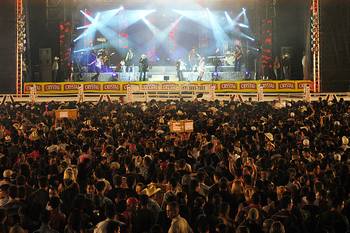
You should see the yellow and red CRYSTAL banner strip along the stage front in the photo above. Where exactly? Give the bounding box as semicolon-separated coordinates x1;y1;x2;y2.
24;80;313;95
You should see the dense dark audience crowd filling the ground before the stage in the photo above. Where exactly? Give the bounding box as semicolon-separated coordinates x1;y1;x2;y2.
0;99;350;233
